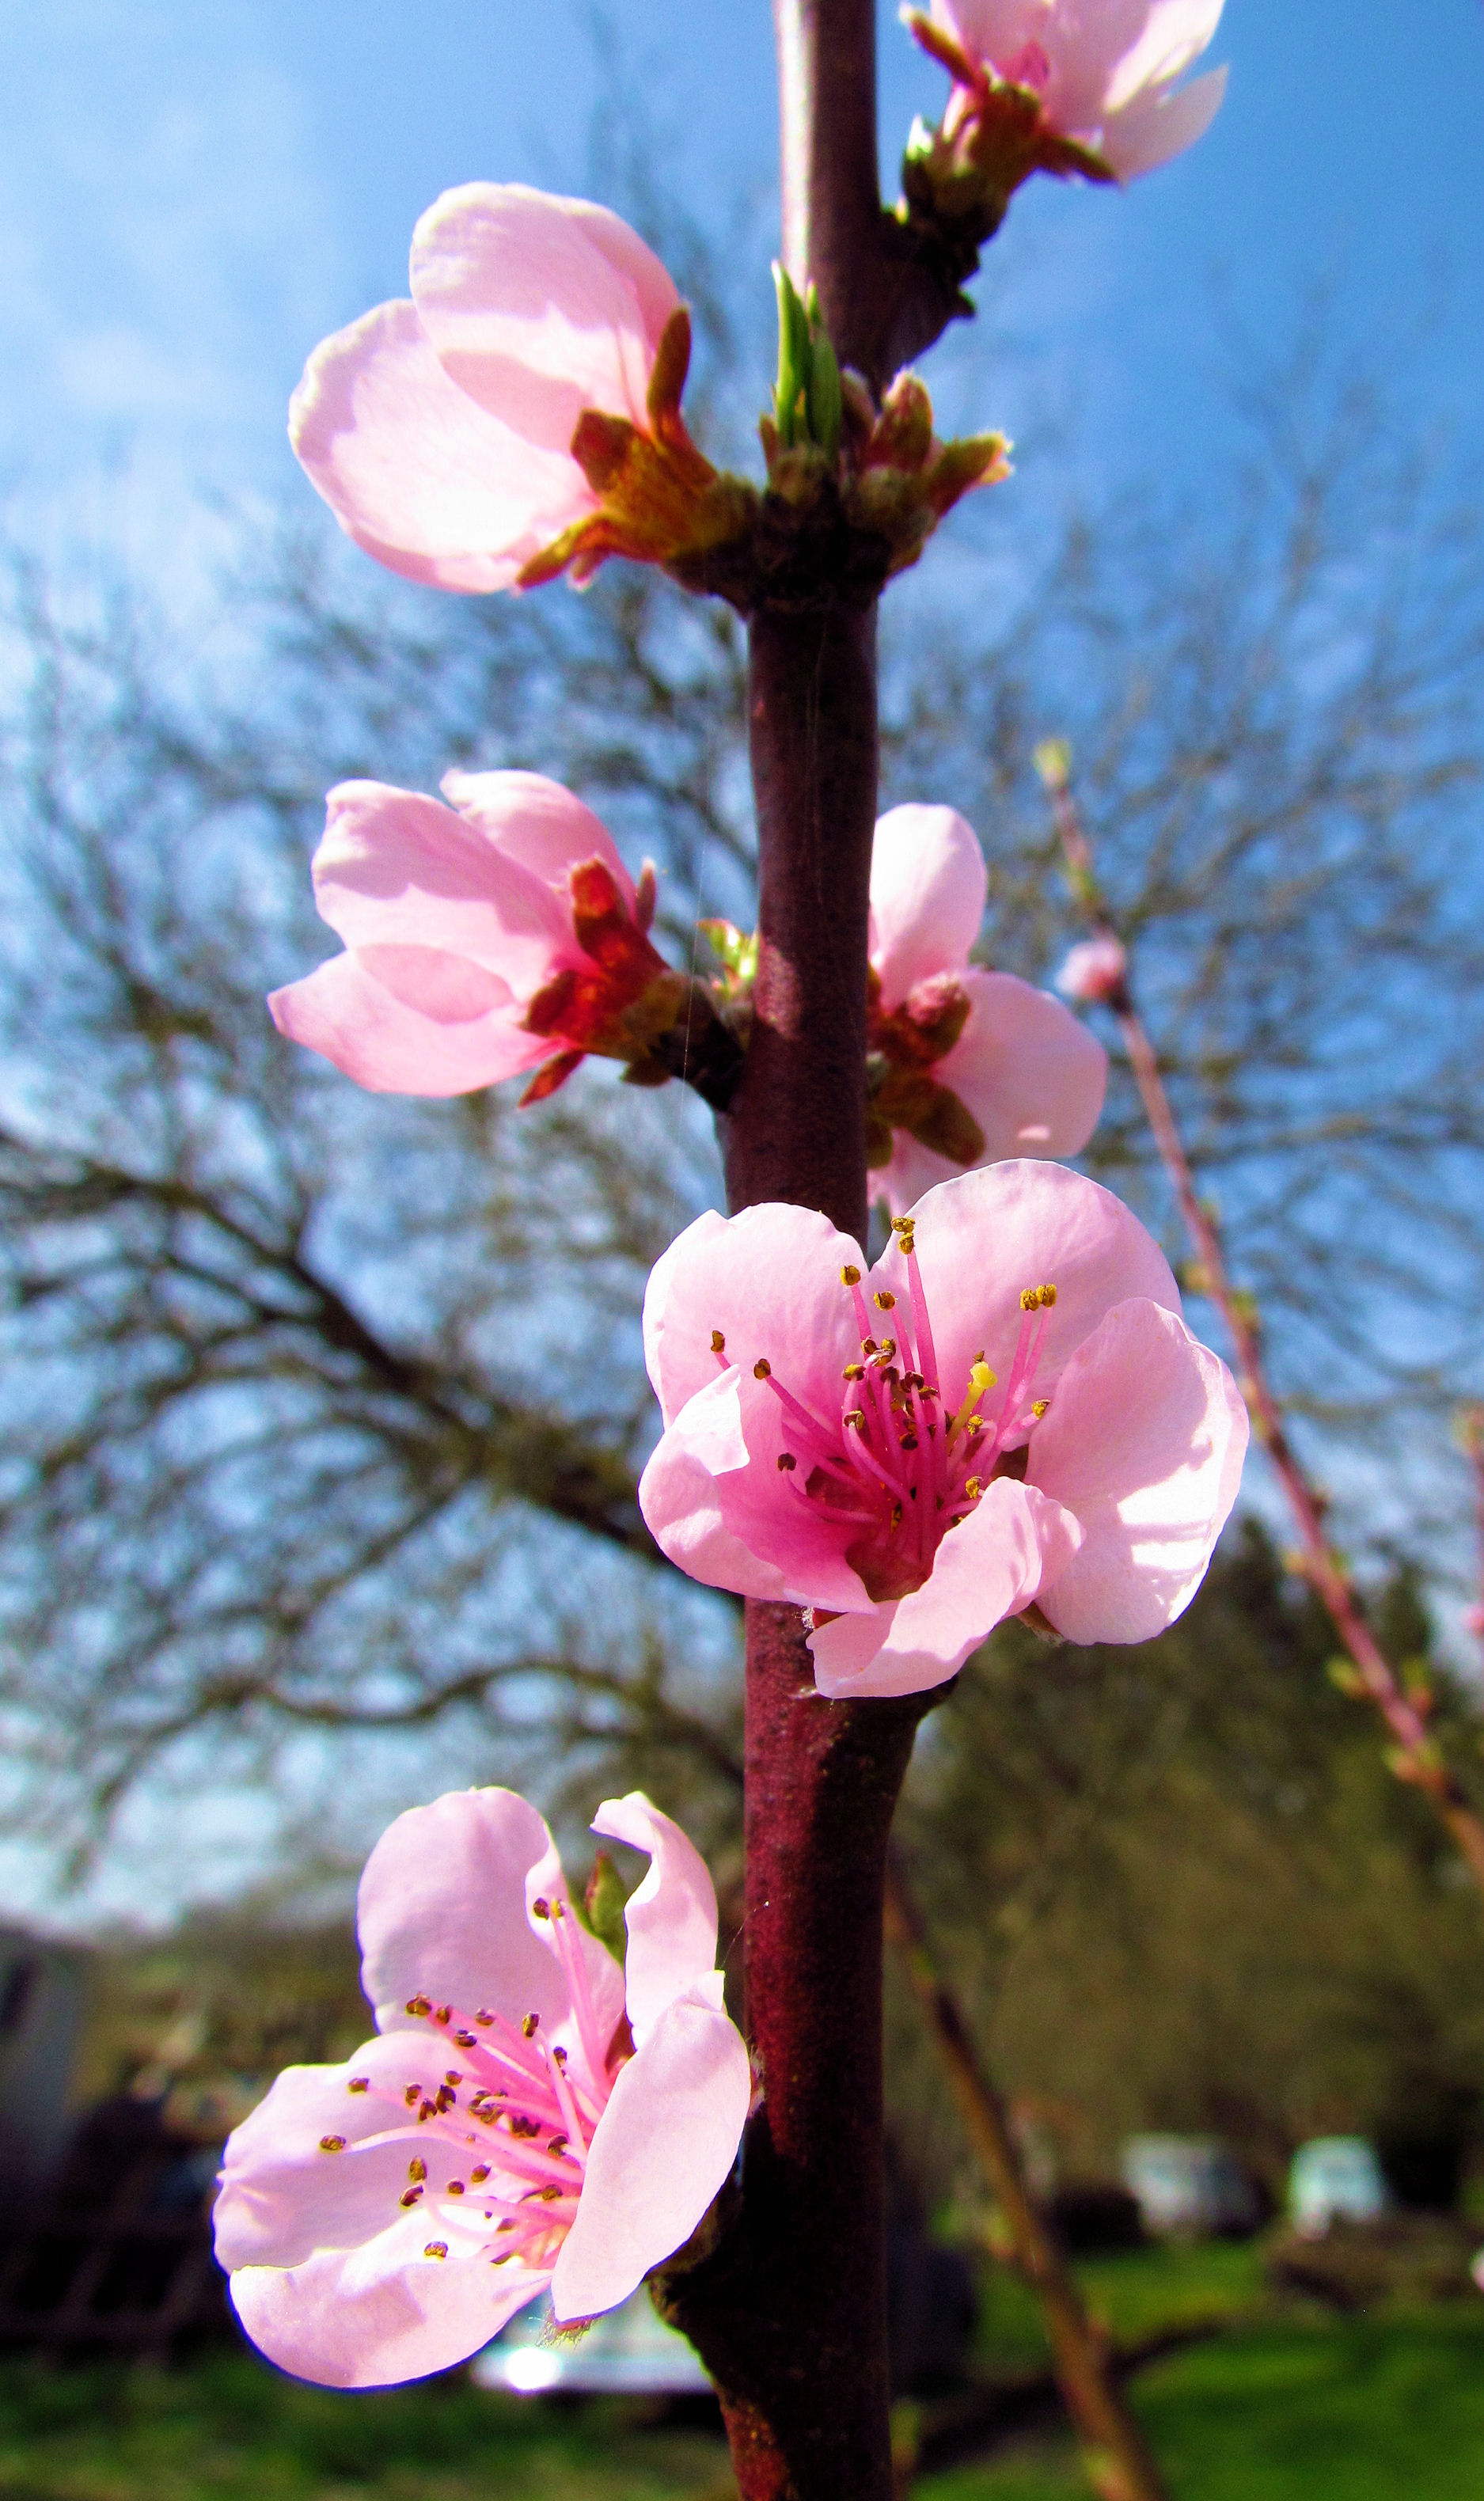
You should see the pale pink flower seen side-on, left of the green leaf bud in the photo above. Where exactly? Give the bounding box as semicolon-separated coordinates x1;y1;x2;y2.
288;183;726;590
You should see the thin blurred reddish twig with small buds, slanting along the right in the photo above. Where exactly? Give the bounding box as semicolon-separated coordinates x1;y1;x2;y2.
1046;770;1484;1888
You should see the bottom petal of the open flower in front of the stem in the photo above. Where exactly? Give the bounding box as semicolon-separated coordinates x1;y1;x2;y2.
808;1475;1081;1701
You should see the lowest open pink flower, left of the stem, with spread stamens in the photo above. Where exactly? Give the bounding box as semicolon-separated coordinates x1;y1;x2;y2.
215;1788;751;2389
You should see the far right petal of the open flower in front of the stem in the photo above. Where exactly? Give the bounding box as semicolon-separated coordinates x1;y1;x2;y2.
1026;1300;1249;1641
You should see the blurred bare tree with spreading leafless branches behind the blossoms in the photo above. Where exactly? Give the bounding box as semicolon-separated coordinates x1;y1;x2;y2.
0;255;1484;1880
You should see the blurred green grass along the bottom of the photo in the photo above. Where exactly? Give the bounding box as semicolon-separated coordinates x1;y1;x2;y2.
0;2280;1484;2501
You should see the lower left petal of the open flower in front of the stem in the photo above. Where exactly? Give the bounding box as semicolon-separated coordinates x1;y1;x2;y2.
638;1361;871;1611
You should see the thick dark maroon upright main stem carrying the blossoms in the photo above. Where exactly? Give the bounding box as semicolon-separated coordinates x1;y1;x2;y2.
666;0;926;2501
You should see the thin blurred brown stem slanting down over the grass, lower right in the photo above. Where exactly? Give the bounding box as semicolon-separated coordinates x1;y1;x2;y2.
886;1861;1169;2501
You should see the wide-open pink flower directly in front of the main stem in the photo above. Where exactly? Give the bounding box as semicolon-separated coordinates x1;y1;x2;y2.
638;1163;1247;1698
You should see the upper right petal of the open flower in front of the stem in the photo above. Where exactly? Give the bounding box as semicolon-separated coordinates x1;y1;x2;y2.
871;1163;1178;1430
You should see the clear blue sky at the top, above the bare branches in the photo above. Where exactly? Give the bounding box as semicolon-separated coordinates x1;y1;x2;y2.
0;0;1484;573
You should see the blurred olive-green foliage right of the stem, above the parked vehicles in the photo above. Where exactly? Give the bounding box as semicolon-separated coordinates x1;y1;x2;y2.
891;1520;1484;2195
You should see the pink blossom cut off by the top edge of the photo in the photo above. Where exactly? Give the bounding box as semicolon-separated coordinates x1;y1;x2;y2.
911;0;1226;183
